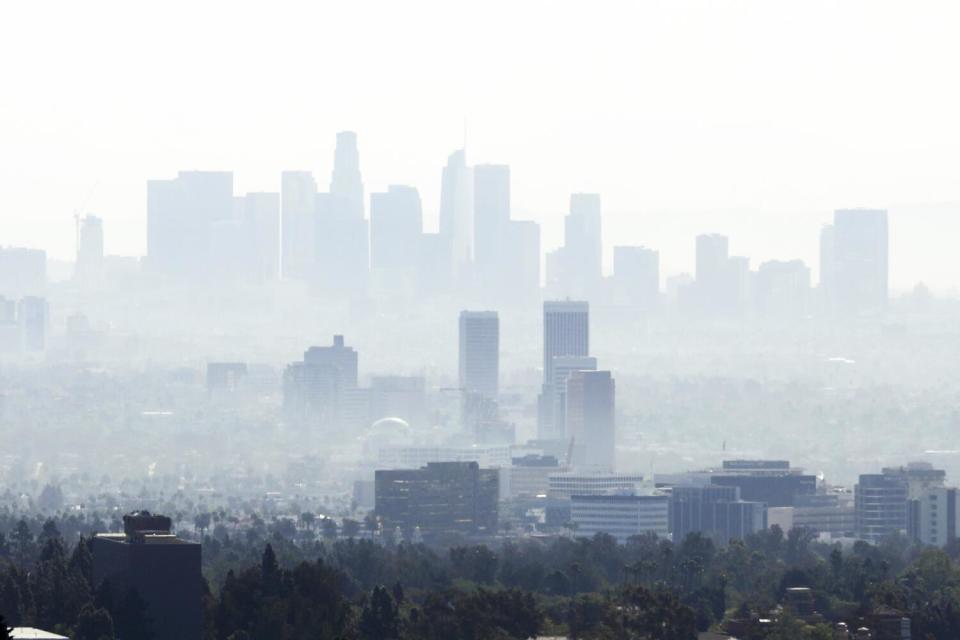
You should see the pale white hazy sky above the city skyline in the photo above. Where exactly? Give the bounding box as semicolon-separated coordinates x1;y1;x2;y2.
0;0;960;288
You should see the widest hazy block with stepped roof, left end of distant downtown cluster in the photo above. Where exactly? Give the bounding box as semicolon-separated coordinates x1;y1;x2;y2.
147;171;233;281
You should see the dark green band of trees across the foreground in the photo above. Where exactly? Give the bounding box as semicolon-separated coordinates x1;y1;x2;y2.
0;520;960;640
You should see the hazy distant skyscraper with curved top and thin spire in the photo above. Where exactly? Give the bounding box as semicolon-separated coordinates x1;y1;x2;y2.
440;149;474;282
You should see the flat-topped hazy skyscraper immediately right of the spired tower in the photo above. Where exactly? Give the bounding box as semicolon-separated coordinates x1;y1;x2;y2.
473;164;510;276
